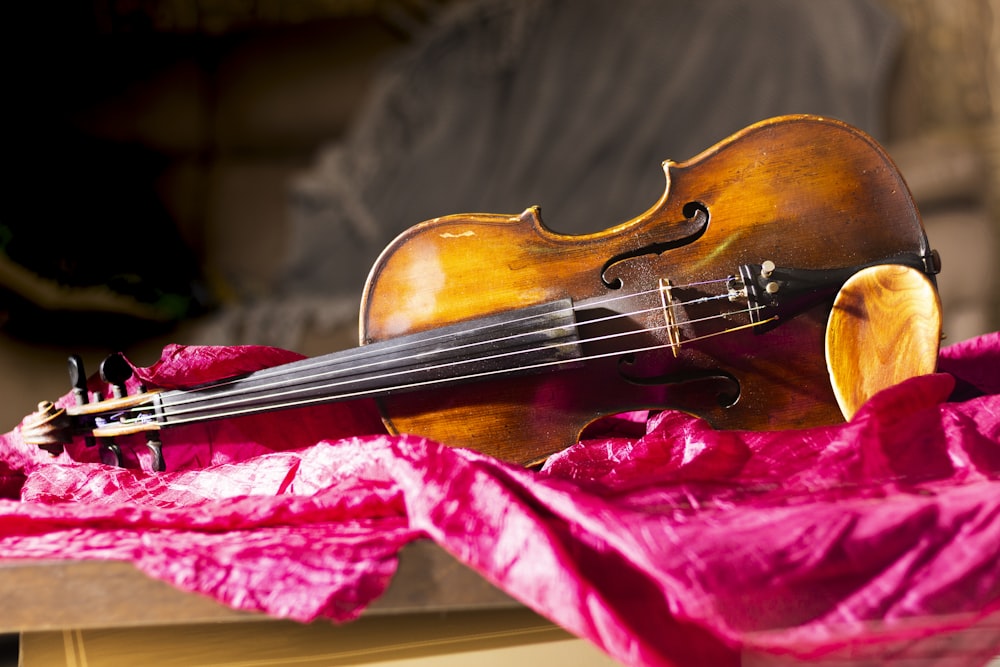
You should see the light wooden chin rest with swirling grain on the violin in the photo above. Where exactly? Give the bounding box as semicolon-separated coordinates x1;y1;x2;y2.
825;265;941;419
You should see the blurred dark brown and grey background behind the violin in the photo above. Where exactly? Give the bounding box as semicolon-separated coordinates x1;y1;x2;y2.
0;0;1000;430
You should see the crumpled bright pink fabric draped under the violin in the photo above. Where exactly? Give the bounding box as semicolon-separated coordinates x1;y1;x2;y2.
0;334;1000;665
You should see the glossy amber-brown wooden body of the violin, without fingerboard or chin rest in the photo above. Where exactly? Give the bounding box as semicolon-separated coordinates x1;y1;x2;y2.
360;116;936;463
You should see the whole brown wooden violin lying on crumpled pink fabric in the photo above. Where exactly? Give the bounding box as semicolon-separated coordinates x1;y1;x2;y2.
23;115;940;467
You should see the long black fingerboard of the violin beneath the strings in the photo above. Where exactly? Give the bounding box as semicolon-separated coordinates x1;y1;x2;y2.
156;299;582;426
